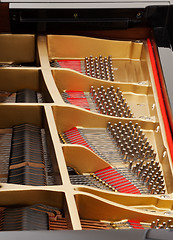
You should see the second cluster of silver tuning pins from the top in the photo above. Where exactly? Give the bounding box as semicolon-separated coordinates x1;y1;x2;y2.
90;86;133;118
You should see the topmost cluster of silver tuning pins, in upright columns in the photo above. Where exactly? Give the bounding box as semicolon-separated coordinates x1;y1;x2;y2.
85;56;115;81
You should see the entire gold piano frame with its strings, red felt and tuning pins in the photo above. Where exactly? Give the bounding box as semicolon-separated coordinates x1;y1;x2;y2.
0;34;173;231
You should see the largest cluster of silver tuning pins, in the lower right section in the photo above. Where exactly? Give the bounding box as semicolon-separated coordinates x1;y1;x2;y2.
107;121;165;194
